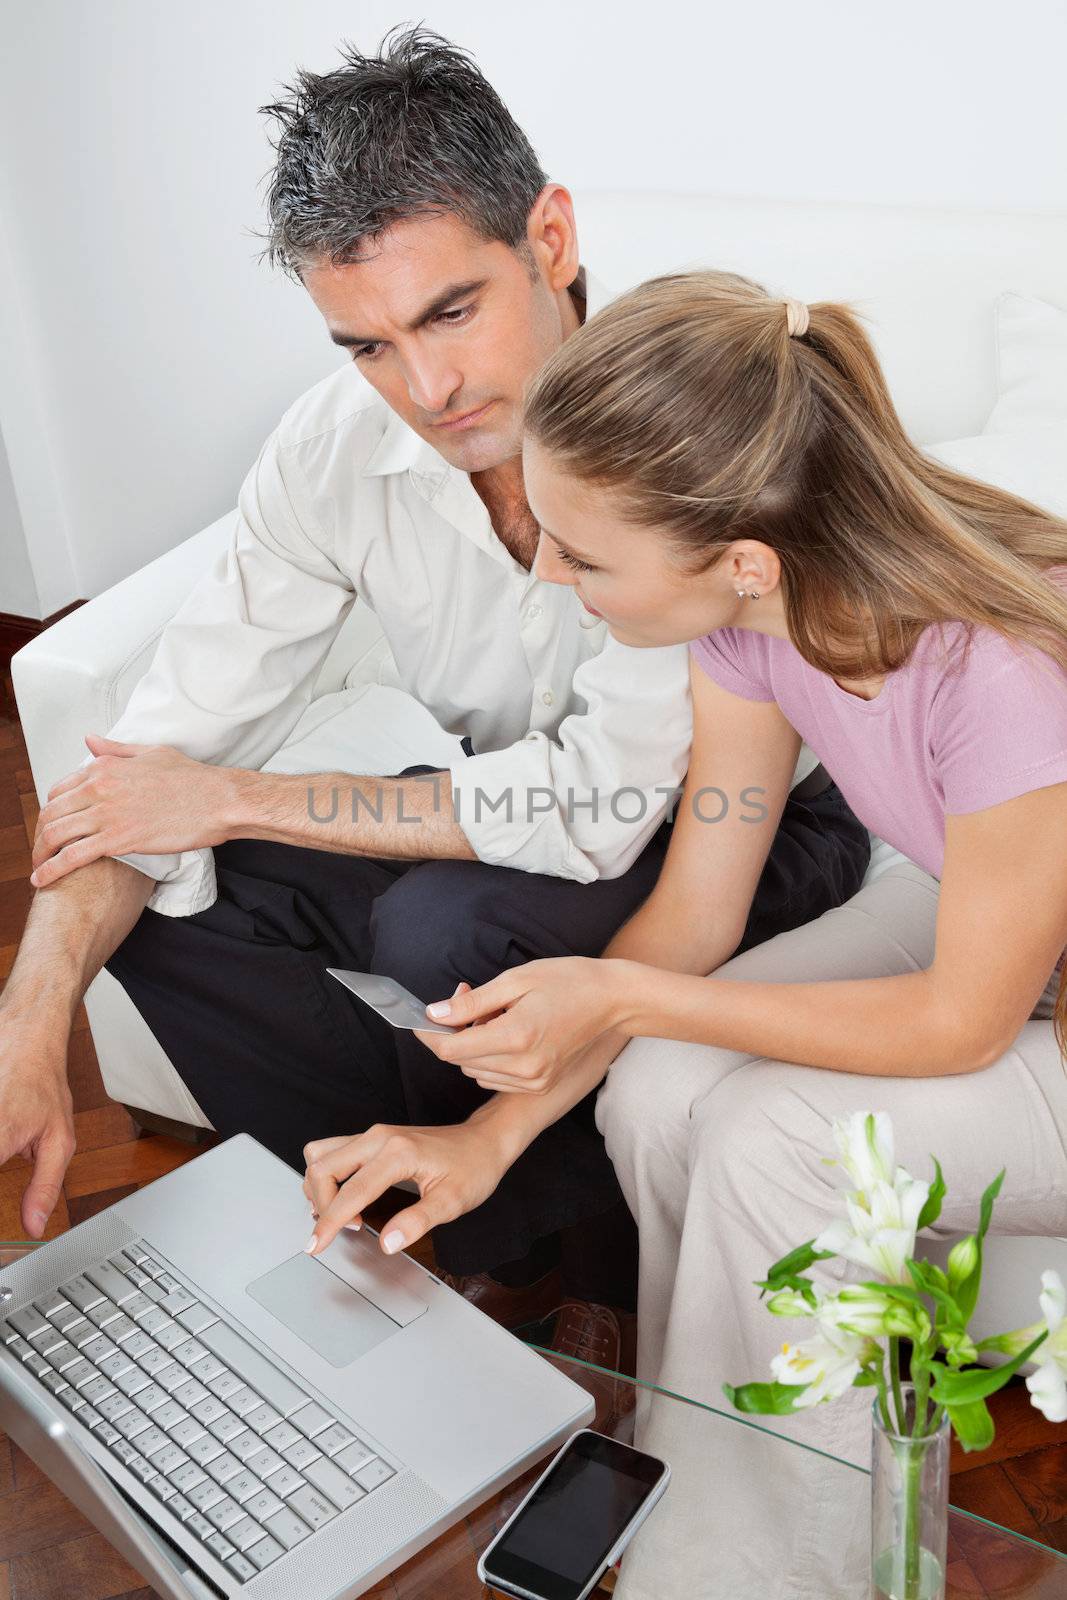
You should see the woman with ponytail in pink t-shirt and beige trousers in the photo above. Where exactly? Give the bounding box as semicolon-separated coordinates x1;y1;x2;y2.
314;274;1067;1600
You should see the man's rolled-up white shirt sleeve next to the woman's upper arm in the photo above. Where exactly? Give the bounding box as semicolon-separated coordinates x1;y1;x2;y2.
451;638;693;883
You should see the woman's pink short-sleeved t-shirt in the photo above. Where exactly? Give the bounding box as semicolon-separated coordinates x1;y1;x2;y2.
689;565;1067;966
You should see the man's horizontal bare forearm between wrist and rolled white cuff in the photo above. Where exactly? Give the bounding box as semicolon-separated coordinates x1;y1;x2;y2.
224;771;477;861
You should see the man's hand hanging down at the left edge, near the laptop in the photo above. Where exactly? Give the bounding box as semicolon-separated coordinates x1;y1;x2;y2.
0;1008;74;1238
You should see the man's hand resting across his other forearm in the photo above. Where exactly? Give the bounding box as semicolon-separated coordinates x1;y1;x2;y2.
30;733;234;888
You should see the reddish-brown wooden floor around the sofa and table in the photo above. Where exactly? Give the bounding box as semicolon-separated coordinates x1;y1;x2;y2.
0;659;1067;1600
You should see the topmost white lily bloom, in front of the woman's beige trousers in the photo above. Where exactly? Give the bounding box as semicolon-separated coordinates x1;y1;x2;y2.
814;1112;929;1283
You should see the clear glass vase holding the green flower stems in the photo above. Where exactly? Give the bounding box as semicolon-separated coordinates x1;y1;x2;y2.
870;1384;952;1600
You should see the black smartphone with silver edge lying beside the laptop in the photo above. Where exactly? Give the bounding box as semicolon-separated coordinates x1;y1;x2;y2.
478;1427;670;1600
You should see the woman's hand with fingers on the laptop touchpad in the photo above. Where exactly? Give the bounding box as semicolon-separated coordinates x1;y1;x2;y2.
304;1113;518;1256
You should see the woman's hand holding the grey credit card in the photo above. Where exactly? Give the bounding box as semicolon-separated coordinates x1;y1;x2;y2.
418;957;633;1094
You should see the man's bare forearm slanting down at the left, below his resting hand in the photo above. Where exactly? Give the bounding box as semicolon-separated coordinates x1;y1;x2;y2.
0;858;155;1035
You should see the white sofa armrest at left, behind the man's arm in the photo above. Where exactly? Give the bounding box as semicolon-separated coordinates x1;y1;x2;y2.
11;512;235;803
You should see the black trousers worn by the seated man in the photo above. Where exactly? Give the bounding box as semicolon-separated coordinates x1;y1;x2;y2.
107;784;870;1274
